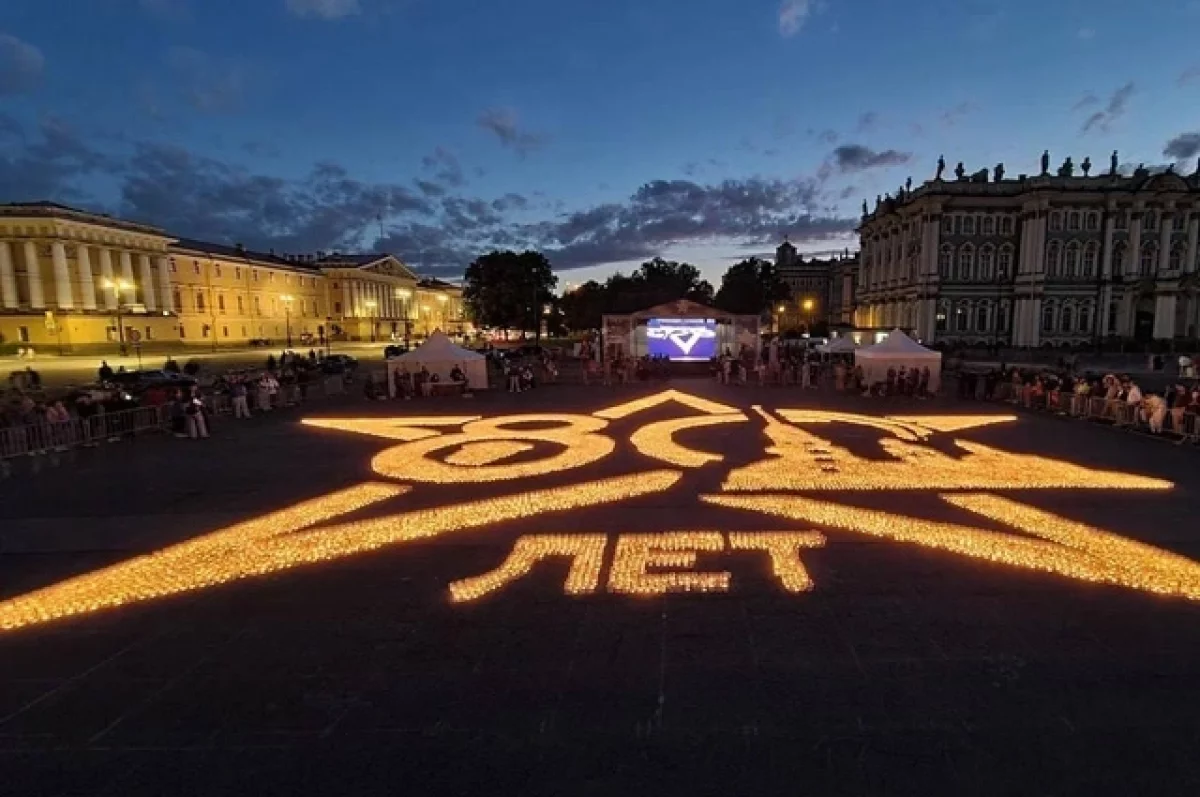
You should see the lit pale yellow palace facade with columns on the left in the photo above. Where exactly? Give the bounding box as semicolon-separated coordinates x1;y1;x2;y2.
0;203;470;352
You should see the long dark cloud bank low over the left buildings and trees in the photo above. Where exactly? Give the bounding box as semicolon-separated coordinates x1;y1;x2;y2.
0;114;854;276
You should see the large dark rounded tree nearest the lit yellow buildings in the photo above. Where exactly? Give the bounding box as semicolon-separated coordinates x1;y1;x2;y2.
462;250;558;335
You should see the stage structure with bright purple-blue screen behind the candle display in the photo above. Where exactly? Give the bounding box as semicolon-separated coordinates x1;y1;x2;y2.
601;299;762;362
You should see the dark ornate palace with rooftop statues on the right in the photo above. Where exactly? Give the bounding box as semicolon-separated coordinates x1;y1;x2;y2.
854;160;1200;347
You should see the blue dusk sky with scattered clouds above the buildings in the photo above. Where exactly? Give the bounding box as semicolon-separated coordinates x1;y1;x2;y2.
0;0;1200;282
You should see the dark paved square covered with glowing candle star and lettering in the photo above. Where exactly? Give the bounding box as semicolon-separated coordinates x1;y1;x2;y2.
0;380;1200;795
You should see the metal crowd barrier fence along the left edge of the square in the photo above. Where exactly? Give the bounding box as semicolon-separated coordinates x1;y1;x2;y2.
0;377;346;460
